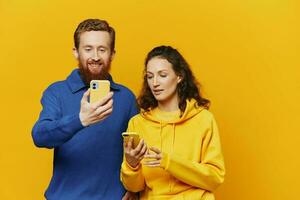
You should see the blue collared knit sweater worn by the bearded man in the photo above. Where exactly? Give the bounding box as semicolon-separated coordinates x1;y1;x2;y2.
32;69;137;200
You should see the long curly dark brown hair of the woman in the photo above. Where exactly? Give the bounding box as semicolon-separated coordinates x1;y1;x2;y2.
137;46;210;113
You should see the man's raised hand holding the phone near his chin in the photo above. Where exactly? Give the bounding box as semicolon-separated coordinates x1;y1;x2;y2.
79;89;113;126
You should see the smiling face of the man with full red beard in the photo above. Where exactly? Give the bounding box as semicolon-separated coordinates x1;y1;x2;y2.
73;31;114;84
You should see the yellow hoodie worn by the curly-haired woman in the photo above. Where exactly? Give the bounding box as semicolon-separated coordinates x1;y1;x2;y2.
121;99;225;200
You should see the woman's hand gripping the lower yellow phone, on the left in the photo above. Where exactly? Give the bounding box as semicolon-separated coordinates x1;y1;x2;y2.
124;137;147;168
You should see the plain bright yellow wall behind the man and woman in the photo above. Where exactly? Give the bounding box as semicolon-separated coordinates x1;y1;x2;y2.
0;0;300;200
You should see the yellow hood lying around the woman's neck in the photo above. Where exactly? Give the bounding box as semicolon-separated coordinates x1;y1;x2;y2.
141;99;204;124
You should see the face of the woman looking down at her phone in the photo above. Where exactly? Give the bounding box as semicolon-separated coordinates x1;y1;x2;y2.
146;57;181;105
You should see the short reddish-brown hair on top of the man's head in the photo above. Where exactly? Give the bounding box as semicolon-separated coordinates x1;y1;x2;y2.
74;19;116;52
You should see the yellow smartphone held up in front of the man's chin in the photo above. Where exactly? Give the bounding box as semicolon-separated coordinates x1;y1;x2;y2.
90;80;110;103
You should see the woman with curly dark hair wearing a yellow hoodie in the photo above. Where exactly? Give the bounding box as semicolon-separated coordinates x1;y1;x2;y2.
121;46;225;200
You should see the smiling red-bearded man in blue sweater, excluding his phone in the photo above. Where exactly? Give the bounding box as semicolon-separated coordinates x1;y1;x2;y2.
32;19;137;200
